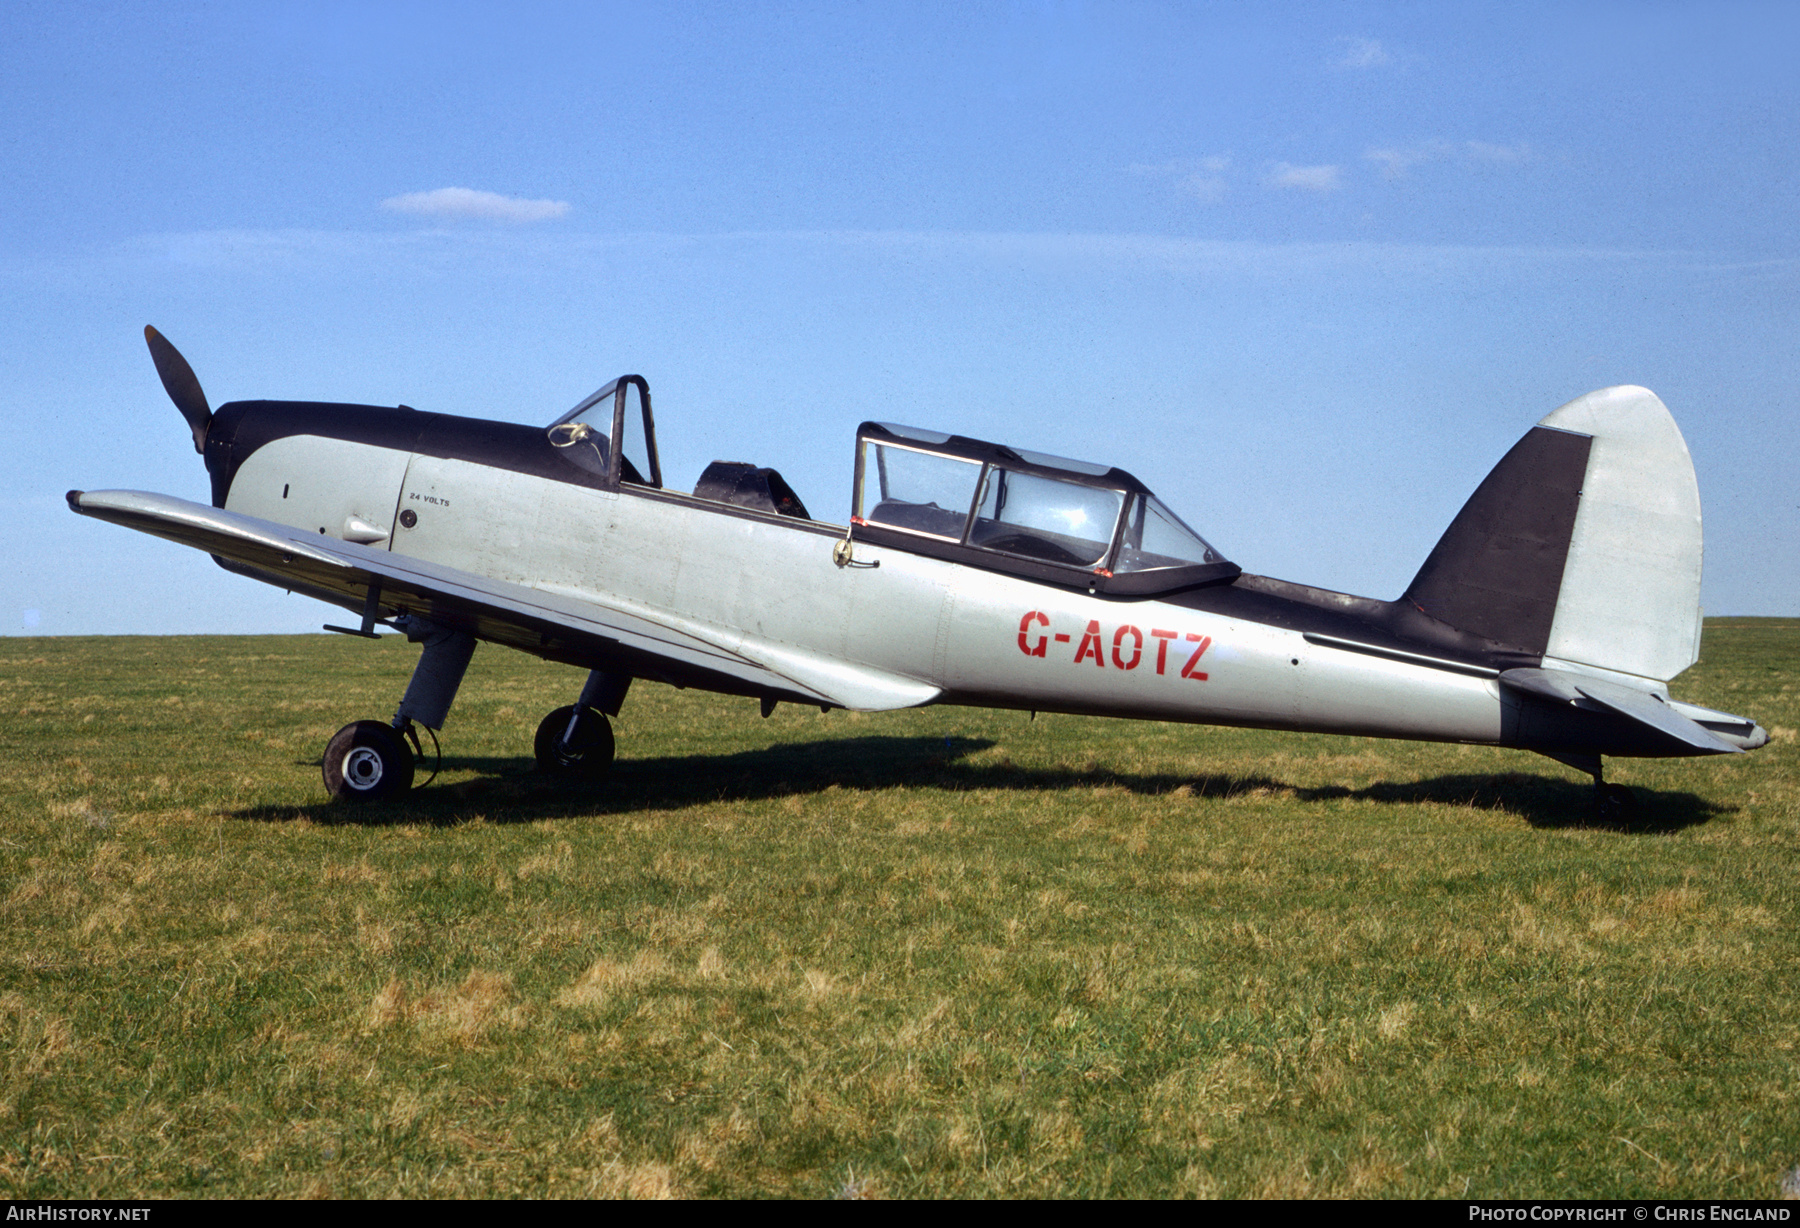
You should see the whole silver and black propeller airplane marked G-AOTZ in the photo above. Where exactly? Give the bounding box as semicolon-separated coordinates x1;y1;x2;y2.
67;328;1769;819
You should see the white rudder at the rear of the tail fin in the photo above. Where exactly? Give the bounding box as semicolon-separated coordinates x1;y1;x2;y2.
1539;387;1701;682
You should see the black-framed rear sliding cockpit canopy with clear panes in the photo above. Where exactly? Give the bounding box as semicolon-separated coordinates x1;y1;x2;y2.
851;421;1238;596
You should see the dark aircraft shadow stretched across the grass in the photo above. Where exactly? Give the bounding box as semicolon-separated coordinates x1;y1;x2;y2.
234;736;1733;834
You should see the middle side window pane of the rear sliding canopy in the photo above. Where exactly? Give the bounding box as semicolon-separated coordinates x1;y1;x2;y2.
968;465;1125;567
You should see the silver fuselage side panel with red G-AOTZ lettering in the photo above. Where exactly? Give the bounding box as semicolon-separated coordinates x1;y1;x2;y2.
225;424;1508;744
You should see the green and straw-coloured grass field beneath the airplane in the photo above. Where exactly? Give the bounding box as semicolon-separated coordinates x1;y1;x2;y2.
0;619;1800;1197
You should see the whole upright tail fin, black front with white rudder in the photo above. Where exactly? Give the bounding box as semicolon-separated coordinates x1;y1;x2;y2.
1404;387;1701;682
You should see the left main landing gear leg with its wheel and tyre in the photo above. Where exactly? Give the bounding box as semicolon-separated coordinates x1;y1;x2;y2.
322;616;475;801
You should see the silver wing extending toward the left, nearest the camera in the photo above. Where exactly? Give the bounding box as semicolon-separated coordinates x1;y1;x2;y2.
68;490;940;711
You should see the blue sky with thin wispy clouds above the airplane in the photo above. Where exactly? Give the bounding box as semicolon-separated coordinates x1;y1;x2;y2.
0;0;1800;634
